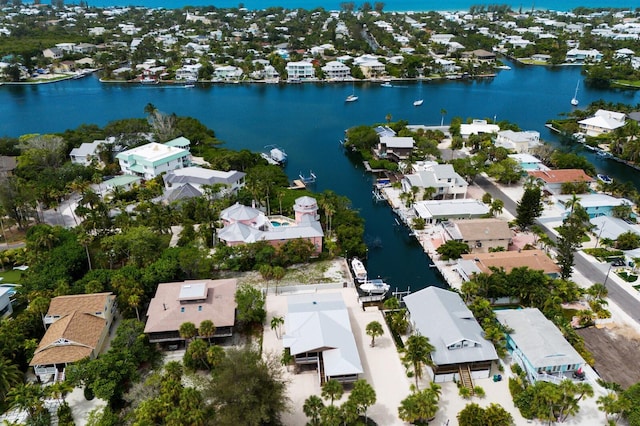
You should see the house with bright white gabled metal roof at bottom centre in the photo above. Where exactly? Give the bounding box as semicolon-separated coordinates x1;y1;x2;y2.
282;293;363;384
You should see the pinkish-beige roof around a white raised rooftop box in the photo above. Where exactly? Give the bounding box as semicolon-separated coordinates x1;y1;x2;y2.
144;279;238;333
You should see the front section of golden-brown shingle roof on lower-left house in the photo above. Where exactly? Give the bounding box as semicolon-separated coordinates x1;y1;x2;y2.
29;311;106;365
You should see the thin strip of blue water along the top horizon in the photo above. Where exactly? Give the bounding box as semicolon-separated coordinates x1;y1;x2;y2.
82;0;637;11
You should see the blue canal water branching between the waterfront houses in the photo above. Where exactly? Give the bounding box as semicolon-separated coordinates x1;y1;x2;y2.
0;63;638;290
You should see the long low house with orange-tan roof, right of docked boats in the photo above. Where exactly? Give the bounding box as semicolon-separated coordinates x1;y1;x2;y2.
456;250;560;281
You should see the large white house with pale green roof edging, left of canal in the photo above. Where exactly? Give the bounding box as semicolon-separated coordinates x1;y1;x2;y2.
116;137;191;179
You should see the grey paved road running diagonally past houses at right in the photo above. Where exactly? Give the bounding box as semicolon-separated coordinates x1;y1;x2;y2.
475;176;640;324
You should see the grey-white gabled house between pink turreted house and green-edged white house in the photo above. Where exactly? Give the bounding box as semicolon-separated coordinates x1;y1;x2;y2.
163;166;246;195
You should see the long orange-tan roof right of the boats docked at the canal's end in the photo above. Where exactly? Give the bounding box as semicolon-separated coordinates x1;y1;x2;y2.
462;250;560;274
